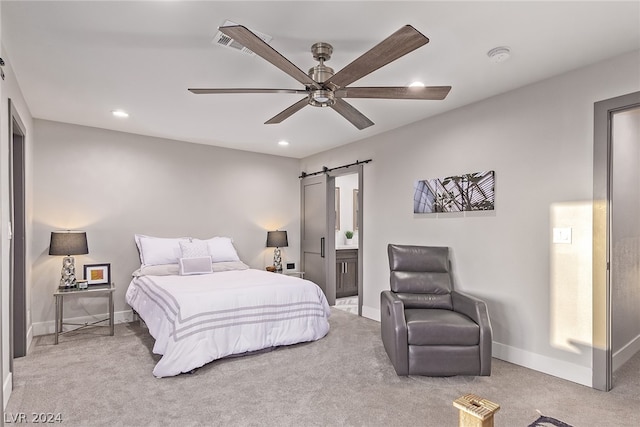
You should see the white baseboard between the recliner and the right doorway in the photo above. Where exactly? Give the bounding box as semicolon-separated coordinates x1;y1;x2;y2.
492;341;593;387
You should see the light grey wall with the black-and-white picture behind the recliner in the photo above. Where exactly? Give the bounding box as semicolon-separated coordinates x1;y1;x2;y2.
301;52;640;385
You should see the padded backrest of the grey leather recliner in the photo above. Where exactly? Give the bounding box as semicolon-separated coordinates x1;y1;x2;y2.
387;244;453;310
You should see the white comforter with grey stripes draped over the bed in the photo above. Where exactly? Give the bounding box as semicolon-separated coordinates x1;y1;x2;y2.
126;269;331;377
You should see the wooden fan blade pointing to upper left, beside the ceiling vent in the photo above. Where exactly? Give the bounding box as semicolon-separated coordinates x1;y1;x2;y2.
218;25;320;88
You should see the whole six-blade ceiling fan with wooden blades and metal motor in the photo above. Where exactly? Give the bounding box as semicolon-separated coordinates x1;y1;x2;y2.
189;25;451;130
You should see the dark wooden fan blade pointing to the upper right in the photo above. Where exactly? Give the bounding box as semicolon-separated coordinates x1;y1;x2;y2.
330;25;429;87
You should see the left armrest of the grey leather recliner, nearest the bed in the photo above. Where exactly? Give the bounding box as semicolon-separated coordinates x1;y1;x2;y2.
380;291;409;375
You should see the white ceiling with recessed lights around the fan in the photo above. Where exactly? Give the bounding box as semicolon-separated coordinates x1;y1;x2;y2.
1;1;640;158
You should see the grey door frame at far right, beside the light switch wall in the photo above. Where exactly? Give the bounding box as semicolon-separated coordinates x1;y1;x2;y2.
592;92;640;391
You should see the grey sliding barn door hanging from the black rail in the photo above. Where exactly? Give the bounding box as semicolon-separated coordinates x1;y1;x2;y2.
300;174;336;305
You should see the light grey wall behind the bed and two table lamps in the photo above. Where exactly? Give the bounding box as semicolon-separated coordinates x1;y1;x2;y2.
31;120;300;335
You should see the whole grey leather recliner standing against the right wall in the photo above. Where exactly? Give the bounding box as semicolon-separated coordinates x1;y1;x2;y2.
380;244;492;377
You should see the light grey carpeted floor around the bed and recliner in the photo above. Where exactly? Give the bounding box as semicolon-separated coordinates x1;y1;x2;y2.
5;309;640;427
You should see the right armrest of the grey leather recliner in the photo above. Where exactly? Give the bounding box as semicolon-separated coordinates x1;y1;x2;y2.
451;291;493;375
